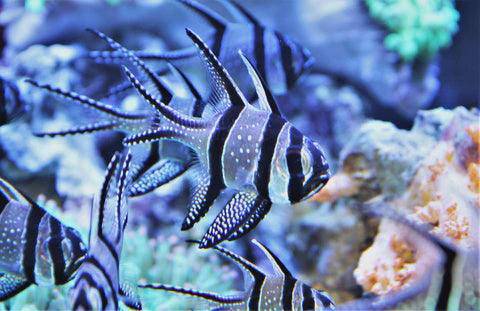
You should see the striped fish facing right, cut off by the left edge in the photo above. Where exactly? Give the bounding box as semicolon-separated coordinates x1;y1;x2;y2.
0;178;86;301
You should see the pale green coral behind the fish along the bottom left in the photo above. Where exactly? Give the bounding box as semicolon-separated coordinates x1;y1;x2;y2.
0;205;238;311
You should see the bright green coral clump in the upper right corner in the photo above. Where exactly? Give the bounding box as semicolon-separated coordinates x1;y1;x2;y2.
365;0;459;61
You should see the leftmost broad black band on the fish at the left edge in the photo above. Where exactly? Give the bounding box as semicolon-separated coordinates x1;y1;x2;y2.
22;204;45;283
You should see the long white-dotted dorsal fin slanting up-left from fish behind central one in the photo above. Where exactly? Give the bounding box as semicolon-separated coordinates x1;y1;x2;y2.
87;29;173;104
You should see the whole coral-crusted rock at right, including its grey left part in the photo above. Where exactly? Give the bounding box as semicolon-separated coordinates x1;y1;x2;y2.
315;108;480;307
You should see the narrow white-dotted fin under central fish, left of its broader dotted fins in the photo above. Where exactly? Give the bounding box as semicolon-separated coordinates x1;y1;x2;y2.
182;175;223;230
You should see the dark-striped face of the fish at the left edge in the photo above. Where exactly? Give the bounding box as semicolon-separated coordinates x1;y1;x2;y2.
62;227;87;281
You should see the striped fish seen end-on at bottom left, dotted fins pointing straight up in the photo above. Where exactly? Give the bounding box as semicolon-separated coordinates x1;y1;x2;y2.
72;152;141;310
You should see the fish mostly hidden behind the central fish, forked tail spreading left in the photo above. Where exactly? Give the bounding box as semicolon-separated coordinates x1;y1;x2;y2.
26;29;205;197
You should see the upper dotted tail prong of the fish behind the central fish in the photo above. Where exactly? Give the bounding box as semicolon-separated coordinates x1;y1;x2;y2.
25;79;148;120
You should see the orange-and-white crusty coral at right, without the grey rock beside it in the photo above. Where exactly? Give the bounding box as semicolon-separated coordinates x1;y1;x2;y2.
355;110;480;302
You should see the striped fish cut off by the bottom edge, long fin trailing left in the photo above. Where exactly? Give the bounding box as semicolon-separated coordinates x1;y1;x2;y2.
139;240;335;310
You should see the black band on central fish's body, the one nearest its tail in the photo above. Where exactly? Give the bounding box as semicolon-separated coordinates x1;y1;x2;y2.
208;106;244;188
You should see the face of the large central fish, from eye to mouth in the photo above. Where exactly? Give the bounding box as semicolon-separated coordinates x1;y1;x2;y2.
300;136;330;200
